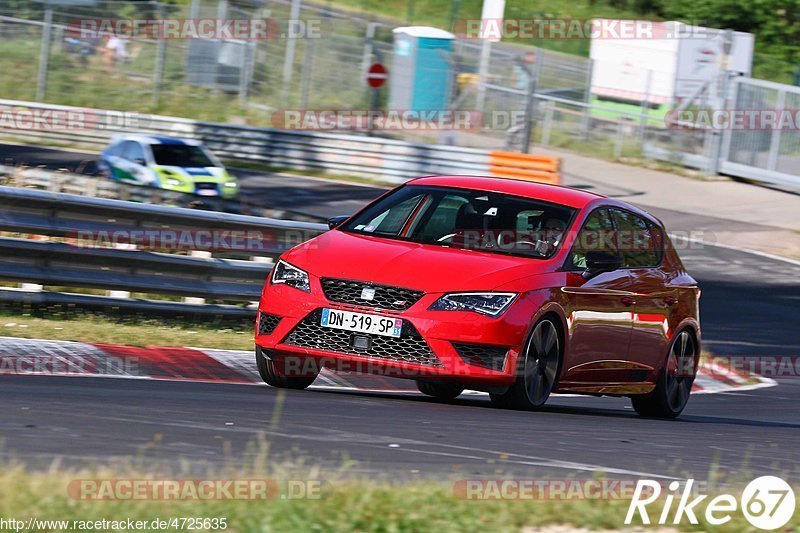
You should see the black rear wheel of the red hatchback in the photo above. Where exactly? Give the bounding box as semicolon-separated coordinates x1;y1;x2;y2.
631;330;697;418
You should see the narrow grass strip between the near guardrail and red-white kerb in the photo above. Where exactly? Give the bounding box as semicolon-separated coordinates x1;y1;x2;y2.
0;311;253;350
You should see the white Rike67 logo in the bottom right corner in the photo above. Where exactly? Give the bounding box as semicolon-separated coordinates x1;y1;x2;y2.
625;476;795;530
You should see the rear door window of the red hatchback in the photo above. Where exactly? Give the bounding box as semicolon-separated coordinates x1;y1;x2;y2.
613;209;663;268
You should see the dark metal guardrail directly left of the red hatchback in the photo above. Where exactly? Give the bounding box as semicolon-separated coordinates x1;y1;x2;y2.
0;186;327;315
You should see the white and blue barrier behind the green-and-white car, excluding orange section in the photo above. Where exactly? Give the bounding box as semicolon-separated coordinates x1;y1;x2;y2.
0;100;564;183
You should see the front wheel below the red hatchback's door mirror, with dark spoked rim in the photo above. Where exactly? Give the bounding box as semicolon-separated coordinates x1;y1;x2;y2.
489;318;561;411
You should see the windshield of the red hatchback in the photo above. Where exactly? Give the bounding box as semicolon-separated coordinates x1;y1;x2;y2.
340;185;575;259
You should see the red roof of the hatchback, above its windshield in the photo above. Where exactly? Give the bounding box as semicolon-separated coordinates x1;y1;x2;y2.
407;176;605;209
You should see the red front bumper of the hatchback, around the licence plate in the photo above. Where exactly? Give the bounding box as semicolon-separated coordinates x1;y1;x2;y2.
255;278;536;387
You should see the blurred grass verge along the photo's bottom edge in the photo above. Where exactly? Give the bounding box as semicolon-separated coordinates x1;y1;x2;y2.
0;456;800;532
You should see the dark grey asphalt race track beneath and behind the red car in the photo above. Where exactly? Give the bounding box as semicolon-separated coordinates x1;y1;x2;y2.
0;142;800;483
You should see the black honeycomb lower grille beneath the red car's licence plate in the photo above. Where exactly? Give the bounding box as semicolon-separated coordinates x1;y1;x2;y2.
284;309;444;366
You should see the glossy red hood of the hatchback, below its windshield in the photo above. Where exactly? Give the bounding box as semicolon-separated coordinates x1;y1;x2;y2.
283;230;550;292
